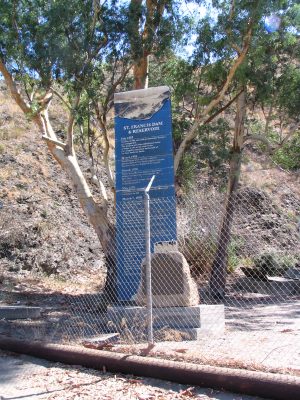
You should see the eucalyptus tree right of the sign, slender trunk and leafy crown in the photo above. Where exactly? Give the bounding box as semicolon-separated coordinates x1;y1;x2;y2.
149;0;300;297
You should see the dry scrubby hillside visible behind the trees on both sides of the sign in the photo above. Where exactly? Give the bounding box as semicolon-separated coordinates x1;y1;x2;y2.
0;82;300;300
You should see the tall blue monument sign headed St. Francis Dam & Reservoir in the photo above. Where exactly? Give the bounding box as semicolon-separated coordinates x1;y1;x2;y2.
114;86;176;301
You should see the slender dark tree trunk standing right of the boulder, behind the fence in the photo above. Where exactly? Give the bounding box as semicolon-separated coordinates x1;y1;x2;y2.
210;90;246;299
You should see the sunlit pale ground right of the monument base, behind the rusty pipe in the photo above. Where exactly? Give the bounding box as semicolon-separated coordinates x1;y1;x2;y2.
105;299;300;379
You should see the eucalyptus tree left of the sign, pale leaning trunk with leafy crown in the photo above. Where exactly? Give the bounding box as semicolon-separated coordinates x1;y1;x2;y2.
0;0;128;300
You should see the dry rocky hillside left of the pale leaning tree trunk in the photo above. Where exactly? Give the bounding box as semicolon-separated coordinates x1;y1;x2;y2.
0;84;103;290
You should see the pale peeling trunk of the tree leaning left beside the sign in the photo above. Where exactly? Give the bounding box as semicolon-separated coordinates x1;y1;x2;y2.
0;59;116;303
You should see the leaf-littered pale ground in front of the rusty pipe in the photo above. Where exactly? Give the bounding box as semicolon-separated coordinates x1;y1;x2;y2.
0;351;268;400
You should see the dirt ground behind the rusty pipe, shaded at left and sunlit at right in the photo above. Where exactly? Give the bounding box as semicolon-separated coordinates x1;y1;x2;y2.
0;276;300;376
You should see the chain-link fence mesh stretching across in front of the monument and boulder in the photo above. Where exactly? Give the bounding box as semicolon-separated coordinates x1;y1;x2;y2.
0;181;300;379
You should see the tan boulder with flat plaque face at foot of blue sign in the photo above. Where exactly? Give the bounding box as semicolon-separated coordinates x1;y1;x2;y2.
134;251;200;307
